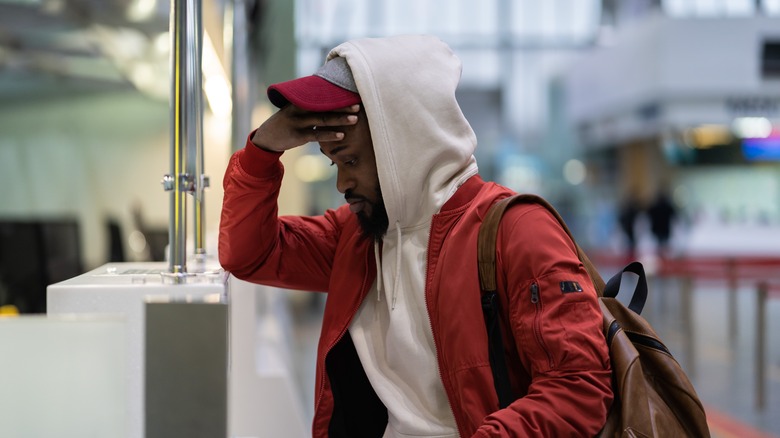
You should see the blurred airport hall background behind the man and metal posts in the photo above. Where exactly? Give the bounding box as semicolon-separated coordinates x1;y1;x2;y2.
0;0;780;436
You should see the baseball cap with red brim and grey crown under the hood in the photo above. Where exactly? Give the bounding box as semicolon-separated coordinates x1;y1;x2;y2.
267;57;360;111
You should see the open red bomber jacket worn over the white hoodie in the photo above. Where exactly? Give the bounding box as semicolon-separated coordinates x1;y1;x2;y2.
219;144;613;438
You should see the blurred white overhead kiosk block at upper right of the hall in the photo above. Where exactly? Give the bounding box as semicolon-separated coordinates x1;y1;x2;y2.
564;16;780;148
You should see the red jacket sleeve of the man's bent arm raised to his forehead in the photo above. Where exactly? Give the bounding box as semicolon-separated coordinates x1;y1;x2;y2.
219;136;343;291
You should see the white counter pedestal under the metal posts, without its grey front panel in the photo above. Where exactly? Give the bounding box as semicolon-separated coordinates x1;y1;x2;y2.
47;263;308;438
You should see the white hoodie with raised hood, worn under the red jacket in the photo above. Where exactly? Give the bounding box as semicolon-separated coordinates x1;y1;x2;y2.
328;36;477;437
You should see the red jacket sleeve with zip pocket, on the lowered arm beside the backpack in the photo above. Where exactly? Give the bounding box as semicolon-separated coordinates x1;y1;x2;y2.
475;205;613;437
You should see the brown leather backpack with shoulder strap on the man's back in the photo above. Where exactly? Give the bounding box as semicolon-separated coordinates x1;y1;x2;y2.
477;194;710;437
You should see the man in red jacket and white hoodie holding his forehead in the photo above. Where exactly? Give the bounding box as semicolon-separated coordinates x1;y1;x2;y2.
219;36;612;437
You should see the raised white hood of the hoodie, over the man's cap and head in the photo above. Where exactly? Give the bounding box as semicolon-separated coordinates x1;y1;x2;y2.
328;35;477;229
